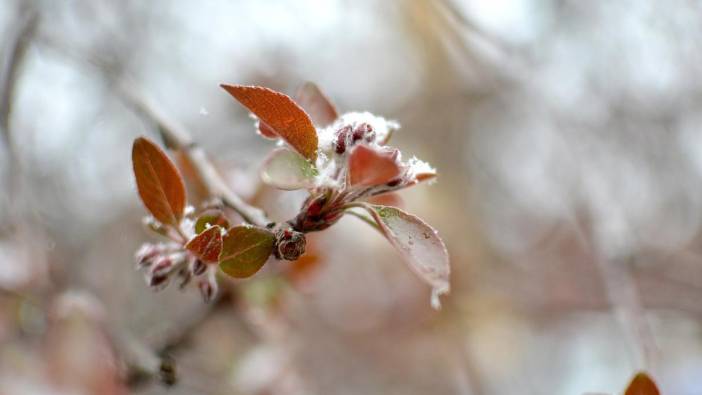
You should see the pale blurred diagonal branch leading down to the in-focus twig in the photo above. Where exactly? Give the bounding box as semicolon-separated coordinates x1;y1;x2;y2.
121;87;272;227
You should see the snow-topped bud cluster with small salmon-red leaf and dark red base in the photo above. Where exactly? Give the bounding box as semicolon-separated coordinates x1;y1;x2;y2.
290;112;436;233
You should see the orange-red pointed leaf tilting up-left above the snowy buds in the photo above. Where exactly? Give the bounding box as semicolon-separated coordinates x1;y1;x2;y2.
221;84;318;161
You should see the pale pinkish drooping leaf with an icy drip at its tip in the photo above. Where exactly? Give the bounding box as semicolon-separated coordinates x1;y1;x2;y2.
362;203;451;309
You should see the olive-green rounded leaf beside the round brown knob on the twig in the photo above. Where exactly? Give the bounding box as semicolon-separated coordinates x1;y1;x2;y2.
219;225;275;278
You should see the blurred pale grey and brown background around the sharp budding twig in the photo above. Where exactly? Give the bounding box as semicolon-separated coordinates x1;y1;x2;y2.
0;0;702;395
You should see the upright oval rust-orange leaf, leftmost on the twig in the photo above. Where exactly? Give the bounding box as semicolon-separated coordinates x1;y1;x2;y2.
132;137;185;226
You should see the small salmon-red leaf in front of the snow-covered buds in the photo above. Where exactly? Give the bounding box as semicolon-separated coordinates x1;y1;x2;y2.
349;145;401;186
